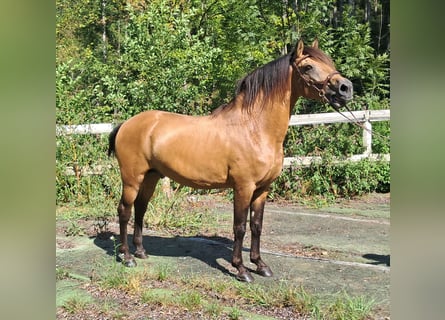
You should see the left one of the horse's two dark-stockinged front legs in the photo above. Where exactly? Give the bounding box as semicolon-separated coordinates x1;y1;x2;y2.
232;189;254;282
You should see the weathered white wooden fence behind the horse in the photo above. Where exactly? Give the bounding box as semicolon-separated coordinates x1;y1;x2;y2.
56;109;391;175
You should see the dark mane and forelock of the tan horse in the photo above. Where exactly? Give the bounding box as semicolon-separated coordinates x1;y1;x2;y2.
212;47;334;115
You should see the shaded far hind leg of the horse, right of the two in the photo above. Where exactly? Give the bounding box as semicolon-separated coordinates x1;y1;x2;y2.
133;171;161;259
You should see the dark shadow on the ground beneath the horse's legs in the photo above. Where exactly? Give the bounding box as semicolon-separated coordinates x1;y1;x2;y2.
93;232;243;276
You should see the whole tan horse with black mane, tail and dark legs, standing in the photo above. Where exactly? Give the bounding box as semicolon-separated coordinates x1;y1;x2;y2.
108;40;353;282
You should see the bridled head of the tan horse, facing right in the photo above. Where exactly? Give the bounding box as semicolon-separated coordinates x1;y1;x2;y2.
292;40;352;110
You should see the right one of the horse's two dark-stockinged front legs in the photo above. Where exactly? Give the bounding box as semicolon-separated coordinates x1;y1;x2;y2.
250;189;273;277
